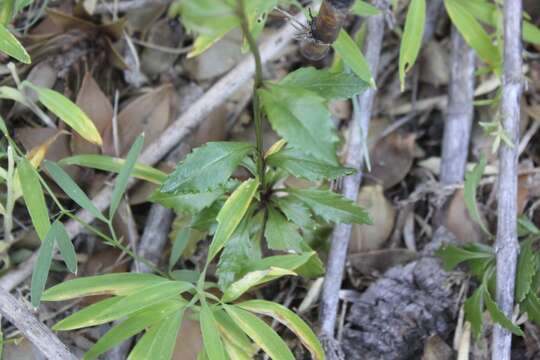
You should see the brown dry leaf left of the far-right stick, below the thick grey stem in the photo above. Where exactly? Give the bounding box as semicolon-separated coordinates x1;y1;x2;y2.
443;189;484;243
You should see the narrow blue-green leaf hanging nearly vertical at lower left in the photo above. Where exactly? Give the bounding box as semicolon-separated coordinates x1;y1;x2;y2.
30;222;57;308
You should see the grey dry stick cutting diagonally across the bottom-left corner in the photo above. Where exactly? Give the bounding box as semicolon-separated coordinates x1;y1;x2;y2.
0;288;77;360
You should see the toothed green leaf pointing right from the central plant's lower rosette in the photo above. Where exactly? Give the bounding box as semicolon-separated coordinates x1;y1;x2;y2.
287;189;372;224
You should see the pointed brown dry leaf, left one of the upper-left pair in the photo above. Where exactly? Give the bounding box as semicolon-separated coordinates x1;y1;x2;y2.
71;72;113;154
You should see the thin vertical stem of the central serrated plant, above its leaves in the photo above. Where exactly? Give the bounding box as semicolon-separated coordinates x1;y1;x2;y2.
238;0;266;193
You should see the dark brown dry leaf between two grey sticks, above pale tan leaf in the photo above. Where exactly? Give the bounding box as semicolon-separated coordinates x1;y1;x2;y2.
369;133;416;189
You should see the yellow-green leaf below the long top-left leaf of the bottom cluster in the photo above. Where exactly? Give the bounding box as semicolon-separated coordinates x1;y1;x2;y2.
52;297;122;331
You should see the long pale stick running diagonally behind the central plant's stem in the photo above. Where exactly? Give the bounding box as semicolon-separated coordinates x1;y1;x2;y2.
0;16;305;289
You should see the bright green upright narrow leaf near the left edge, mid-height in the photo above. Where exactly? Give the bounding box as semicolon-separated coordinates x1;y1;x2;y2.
17;158;51;241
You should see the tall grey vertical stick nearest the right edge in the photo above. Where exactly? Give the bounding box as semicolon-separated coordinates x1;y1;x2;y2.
491;0;522;360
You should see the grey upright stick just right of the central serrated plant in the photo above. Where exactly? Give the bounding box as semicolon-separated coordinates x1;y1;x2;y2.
320;1;388;344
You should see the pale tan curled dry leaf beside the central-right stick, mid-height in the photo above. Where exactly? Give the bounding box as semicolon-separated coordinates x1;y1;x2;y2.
349;185;396;254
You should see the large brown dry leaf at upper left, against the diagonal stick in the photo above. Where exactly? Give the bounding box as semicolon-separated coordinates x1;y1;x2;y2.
103;85;173;156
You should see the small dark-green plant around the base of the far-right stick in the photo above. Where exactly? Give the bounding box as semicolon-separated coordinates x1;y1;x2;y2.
437;158;540;337
